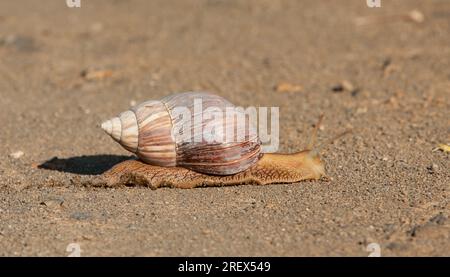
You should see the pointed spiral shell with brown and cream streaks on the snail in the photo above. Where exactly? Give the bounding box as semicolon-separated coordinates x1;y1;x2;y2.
101;92;261;175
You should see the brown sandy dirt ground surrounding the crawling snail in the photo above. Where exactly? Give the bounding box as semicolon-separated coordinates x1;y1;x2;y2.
0;0;450;256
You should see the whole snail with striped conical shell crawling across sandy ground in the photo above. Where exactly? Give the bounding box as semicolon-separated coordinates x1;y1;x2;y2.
96;92;347;188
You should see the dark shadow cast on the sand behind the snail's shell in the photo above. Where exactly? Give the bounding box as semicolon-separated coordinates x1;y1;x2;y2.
38;155;133;175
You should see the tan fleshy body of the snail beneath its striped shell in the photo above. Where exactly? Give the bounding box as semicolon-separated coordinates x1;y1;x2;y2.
96;150;326;189
